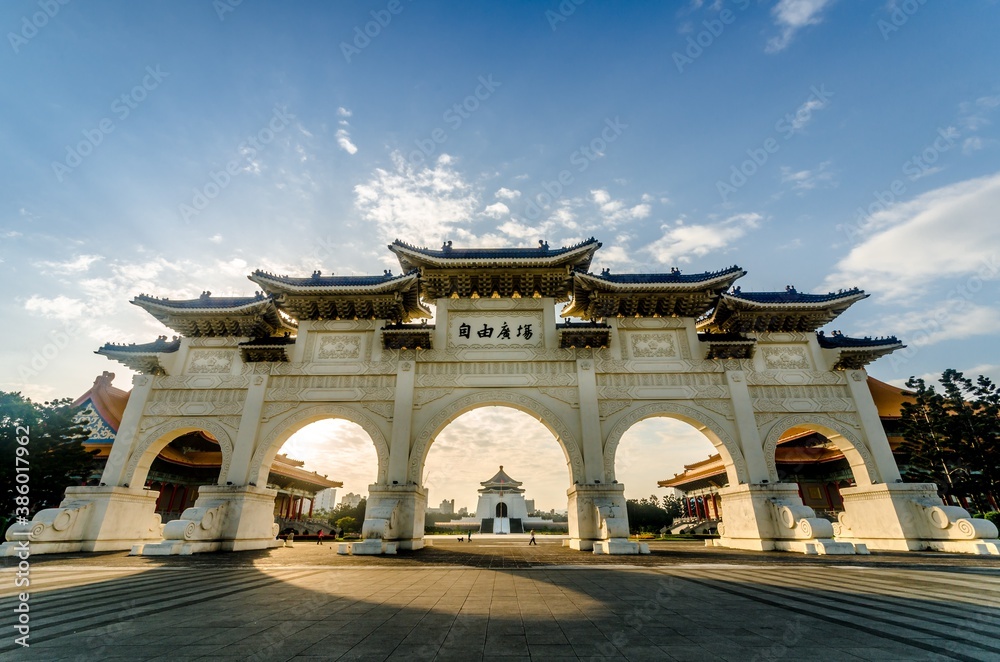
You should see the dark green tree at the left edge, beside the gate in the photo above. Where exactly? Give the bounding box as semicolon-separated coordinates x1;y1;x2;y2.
0;392;94;517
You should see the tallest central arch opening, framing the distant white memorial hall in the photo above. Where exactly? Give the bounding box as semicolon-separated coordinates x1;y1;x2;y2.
422;405;570;535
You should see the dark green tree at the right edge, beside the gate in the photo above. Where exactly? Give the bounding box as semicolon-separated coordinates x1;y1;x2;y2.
900;369;1000;510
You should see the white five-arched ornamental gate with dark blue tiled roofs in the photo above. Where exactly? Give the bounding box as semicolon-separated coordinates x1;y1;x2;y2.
7;239;997;554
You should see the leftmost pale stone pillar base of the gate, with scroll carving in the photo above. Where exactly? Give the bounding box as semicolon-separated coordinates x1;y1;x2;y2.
0;486;163;556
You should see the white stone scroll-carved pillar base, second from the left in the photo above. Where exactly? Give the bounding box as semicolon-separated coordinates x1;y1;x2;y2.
139;485;282;556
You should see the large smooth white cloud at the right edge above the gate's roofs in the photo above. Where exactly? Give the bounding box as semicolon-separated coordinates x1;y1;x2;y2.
826;173;1000;299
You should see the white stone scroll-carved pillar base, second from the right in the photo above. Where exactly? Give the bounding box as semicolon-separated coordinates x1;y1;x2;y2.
715;483;867;554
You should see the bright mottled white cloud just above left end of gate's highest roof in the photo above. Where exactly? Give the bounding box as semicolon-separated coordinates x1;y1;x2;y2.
354;152;480;246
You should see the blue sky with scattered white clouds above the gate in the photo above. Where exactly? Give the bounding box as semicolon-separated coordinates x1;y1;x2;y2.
0;0;1000;505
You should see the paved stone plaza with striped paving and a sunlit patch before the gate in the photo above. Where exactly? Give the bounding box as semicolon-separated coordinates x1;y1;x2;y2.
0;538;1000;661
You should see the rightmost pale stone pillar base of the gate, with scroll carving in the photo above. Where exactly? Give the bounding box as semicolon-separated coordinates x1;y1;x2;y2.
835;483;1000;556
